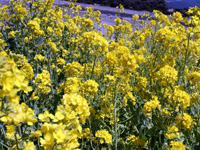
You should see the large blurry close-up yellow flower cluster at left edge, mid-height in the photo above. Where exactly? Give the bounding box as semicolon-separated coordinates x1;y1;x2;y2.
0;56;32;104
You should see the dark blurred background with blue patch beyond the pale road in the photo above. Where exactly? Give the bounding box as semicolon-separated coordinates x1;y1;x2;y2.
71;0;200;15
